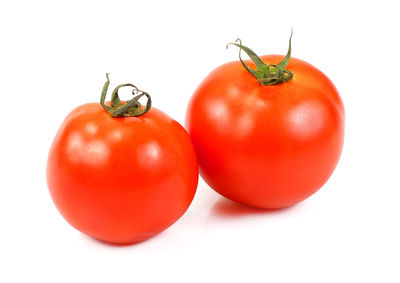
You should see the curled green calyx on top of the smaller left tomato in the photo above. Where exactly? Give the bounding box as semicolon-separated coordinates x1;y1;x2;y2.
100;73;151;118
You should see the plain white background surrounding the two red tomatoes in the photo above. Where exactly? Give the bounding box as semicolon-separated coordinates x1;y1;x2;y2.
0;0;400;282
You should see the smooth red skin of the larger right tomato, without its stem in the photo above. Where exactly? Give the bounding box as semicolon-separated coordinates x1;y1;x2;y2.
186;55;344;209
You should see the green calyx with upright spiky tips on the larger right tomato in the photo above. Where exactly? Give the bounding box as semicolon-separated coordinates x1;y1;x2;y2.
226;31;293;86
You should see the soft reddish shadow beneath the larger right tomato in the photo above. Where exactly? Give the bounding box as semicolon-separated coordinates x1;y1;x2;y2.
210;198;297;218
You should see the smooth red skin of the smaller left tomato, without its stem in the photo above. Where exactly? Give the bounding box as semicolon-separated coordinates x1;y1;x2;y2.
47;103;198;244
